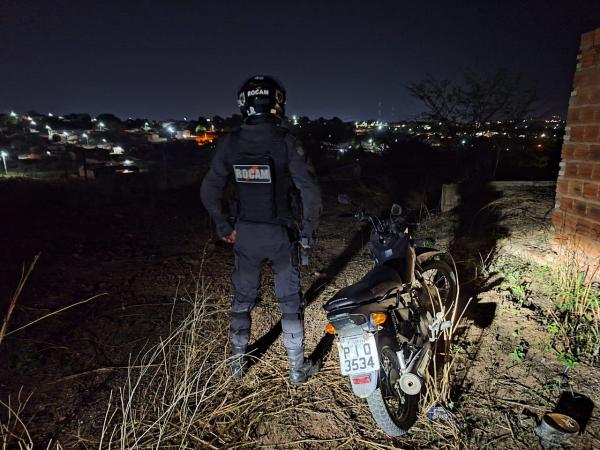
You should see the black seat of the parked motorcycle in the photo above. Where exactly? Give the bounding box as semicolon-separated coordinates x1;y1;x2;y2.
323;265;403;312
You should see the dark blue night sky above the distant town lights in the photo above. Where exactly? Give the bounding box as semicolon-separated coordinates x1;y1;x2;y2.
0;0;600;120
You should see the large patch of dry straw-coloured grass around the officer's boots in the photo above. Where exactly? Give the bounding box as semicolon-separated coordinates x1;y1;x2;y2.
88;255;472;449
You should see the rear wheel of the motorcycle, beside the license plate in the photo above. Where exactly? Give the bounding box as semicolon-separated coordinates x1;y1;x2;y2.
367;342;419;437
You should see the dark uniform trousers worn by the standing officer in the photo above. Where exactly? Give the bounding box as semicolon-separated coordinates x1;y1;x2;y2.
229;222;304;350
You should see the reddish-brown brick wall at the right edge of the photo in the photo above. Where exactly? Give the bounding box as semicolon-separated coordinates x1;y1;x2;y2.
552;28;600;264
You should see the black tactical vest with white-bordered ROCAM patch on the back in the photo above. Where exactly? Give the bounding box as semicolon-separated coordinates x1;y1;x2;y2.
227;127;296;226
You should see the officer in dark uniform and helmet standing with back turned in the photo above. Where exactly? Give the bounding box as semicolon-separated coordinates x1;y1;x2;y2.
201;76;321;385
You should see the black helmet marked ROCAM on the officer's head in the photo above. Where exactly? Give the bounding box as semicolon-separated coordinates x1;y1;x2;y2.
238;75;285;119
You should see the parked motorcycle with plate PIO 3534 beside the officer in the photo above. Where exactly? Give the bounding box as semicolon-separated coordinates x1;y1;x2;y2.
323;194;458;436
